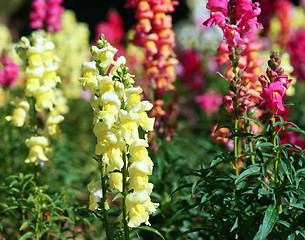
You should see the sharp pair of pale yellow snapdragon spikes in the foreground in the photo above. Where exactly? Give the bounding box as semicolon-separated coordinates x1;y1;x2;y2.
79;35;158;239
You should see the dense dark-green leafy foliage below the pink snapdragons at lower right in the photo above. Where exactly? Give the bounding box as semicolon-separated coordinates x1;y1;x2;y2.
179;118;305;240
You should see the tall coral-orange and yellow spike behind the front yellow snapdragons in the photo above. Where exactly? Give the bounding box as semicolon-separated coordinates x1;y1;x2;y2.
125;0;178;142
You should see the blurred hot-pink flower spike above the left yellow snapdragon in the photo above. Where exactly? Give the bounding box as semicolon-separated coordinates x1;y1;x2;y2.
30;0;64;32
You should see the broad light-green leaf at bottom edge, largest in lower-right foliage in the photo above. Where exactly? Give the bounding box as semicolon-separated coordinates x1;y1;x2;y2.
253;204;279;240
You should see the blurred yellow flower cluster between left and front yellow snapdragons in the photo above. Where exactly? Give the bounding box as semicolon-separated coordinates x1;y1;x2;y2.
48;10;90;98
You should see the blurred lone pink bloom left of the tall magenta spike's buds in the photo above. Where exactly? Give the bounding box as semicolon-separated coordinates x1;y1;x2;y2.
195;92;222;114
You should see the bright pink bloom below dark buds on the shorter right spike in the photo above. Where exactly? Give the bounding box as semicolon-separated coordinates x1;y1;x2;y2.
260;82;285;115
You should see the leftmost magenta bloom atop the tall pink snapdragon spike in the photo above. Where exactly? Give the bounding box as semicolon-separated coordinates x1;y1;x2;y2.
203;0;228;27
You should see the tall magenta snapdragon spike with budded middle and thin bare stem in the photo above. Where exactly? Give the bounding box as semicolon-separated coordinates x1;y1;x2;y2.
204;0;262;173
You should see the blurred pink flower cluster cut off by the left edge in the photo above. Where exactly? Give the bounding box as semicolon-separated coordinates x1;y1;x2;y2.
0;56;19;89
